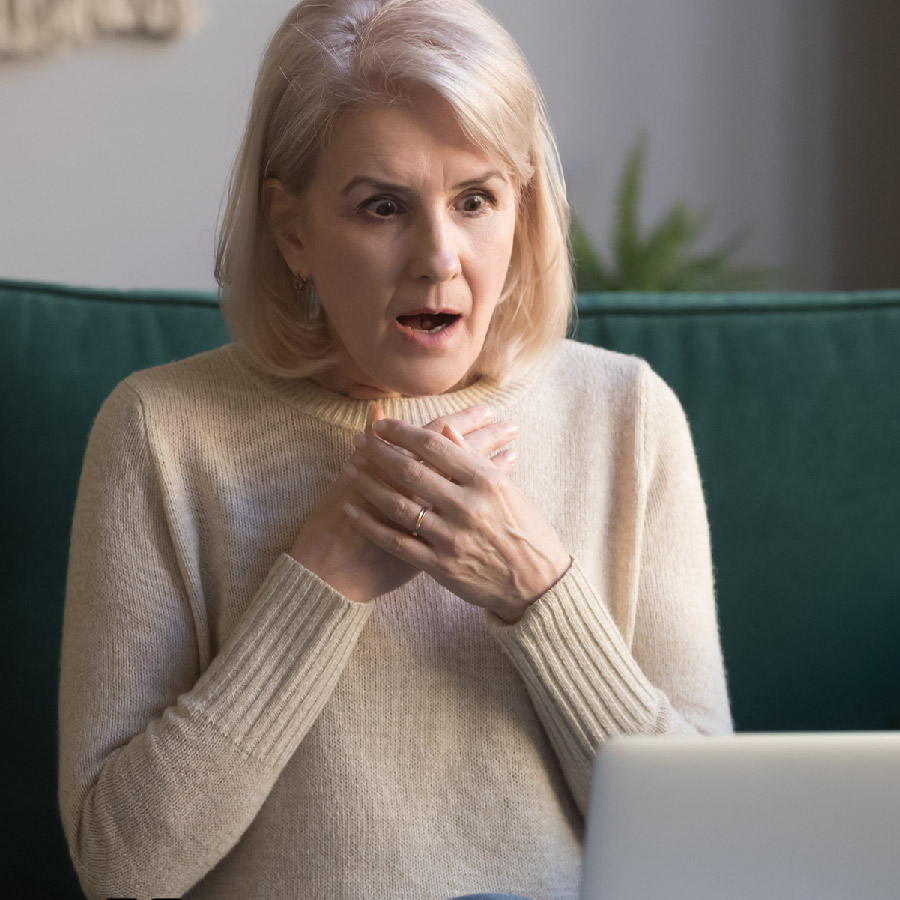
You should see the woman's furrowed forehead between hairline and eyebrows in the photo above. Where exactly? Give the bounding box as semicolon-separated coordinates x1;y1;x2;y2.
314;95;511;187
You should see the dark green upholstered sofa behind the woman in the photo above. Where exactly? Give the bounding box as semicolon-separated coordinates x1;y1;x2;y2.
0;282;900;900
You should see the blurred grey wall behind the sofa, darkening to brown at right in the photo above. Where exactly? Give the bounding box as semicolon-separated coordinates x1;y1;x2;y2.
0;0;900;290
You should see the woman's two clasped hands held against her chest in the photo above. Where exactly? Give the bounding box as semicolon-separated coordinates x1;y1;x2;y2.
292;404;571;622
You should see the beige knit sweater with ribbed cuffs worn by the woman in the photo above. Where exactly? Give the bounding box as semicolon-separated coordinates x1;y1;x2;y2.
60;342;731;900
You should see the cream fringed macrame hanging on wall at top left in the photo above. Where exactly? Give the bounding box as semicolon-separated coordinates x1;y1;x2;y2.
0;0;200;59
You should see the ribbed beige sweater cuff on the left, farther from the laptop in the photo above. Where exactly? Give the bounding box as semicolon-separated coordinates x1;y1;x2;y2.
194;555;372;766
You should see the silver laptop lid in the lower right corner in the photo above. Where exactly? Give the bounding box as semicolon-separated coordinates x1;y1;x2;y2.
581;732;900;900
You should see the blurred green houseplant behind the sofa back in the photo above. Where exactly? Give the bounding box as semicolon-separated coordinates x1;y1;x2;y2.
570;135;773;291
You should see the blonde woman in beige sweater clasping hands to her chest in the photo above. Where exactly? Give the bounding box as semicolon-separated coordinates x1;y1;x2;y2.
60;0;730;900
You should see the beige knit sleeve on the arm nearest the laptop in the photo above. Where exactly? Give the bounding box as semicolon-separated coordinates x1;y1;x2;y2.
488;367;732;812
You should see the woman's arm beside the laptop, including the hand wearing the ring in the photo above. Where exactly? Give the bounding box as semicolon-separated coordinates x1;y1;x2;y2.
348;366;731;809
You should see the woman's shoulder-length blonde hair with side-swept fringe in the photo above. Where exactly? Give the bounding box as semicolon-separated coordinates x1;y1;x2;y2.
215;0;573;381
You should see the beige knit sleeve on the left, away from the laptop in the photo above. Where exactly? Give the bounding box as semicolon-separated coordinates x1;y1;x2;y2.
59;383;370;898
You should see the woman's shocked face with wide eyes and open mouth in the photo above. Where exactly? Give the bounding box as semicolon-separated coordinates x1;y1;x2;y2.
280;95;516;397
